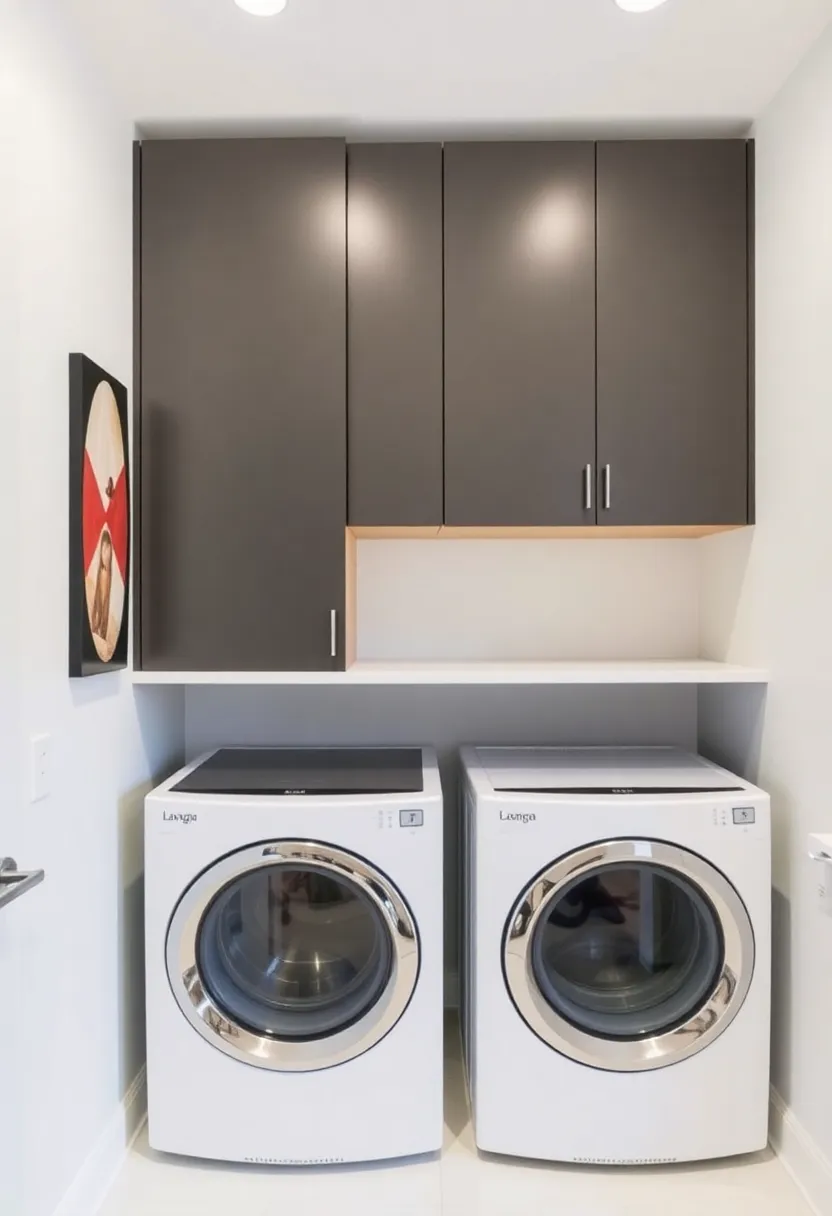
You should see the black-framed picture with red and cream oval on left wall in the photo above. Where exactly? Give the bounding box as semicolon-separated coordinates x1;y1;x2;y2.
69;354;131;679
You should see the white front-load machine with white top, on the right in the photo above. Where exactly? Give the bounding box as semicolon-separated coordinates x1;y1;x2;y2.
462;748;771;1165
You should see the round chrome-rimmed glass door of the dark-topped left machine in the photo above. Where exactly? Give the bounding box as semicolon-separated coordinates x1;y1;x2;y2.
167;840;420;1071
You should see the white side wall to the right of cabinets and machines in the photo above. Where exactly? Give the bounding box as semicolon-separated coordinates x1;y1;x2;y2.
701;19;832;1212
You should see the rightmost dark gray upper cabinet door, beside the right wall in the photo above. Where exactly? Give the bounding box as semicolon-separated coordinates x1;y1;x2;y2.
597;140;749;525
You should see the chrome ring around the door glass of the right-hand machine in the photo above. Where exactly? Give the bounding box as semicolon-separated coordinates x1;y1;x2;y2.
502;839;754;1073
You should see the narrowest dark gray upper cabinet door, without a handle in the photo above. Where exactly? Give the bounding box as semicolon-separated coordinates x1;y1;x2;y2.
347;143;443;527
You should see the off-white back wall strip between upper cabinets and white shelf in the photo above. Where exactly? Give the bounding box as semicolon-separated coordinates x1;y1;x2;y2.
356;540;699;659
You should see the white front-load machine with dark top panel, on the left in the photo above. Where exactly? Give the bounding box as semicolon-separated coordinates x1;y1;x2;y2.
145;748;443;1165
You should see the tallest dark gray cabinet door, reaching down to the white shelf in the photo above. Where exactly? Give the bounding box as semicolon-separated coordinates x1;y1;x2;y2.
140;140;347;671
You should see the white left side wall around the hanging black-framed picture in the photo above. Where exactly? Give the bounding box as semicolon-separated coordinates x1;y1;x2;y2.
6;0;184;1216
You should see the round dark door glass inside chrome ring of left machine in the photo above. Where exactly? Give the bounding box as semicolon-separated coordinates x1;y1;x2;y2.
197;865;393;1041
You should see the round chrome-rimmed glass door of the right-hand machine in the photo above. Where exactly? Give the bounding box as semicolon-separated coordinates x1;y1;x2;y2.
502;839;754;1073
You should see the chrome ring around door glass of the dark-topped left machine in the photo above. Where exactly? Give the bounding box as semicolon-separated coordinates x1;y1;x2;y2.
165;840;420;1073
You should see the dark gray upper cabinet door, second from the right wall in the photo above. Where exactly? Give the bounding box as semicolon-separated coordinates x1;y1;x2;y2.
445;142;595;527
